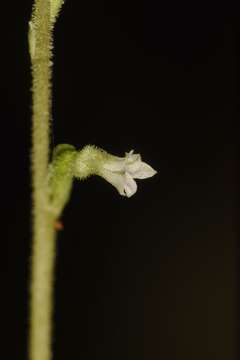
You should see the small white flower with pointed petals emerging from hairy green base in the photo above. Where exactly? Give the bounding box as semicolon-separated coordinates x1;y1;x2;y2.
99;150;157;197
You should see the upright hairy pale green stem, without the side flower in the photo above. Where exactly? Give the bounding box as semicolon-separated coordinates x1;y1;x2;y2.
29;0;56;360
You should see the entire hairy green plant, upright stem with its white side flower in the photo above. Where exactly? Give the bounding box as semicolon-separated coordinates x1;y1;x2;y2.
28;0;156;360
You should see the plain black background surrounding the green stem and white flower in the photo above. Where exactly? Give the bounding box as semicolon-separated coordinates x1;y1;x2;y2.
0;0;240;360
